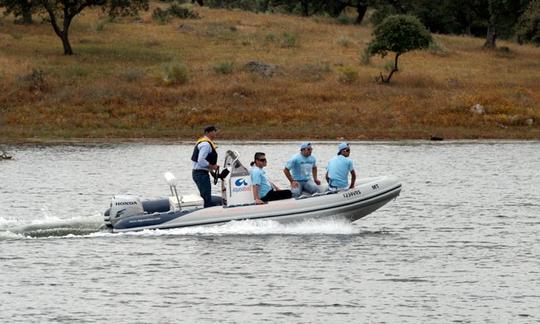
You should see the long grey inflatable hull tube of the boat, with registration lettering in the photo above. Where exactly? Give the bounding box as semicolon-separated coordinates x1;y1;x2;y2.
110;176;401;232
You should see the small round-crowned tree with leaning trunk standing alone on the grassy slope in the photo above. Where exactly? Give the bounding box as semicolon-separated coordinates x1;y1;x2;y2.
367;15;431;83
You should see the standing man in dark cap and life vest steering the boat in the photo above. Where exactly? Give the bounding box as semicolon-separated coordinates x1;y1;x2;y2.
191;126;219;208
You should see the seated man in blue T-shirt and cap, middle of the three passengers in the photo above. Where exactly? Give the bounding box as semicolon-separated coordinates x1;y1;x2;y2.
283;142;321;197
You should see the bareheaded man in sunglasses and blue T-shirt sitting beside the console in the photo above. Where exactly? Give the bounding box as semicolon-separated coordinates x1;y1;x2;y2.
251;152;292;204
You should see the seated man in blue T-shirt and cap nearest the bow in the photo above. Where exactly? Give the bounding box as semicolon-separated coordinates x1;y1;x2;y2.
326;143;356;190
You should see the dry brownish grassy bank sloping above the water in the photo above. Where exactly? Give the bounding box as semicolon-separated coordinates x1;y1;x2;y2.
0;4;540;142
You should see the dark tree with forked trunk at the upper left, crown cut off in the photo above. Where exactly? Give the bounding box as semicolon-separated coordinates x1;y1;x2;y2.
38;0;148;55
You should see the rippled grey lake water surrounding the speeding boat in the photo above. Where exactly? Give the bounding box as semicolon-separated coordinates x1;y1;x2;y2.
0;142;540;323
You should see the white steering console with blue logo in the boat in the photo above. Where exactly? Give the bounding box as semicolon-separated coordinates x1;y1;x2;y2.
221;151;255;206
